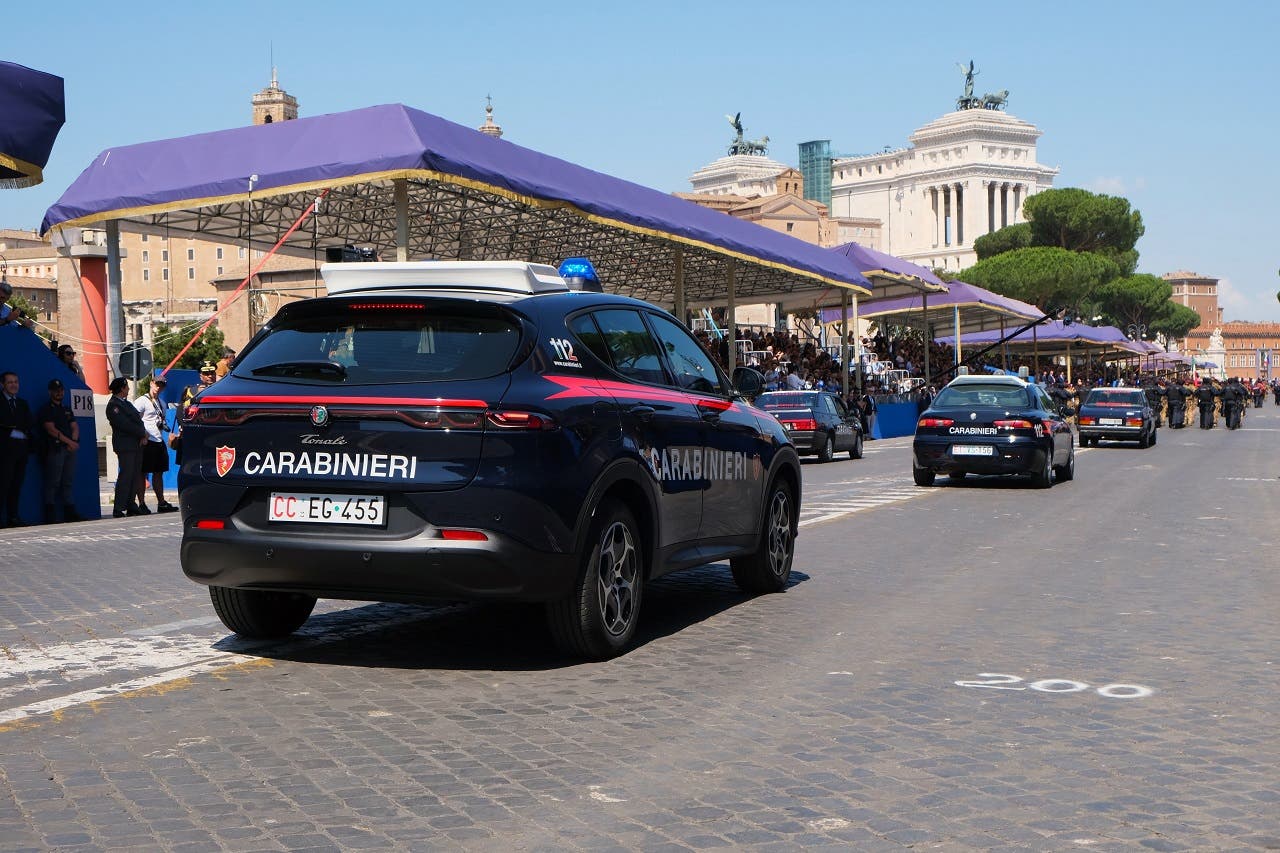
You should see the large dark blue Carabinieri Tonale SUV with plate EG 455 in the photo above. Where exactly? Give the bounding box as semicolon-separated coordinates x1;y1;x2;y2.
179;261;801;658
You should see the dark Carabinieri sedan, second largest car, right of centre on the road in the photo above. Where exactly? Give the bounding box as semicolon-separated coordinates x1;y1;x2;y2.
911;377;1075;488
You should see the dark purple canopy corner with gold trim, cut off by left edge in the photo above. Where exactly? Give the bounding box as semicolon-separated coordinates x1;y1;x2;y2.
0;61;67;188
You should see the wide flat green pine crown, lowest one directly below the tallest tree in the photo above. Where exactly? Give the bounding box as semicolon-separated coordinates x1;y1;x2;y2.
961;246;1119;313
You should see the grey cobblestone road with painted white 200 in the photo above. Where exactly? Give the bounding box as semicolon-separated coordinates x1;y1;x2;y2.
0;407;1280;850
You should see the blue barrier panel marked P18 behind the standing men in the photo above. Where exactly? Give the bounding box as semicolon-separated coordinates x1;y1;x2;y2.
0;324;101;524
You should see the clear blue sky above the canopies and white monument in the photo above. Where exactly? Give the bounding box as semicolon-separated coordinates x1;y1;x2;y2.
0;0;1280;320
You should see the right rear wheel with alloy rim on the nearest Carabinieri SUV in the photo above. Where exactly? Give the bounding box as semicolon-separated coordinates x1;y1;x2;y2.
547;500;645;661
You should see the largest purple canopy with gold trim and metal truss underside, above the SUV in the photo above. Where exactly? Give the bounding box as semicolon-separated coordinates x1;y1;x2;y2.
42;104;869;315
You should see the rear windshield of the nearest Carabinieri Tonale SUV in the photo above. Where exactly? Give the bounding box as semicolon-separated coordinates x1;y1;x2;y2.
236;304;521;384
